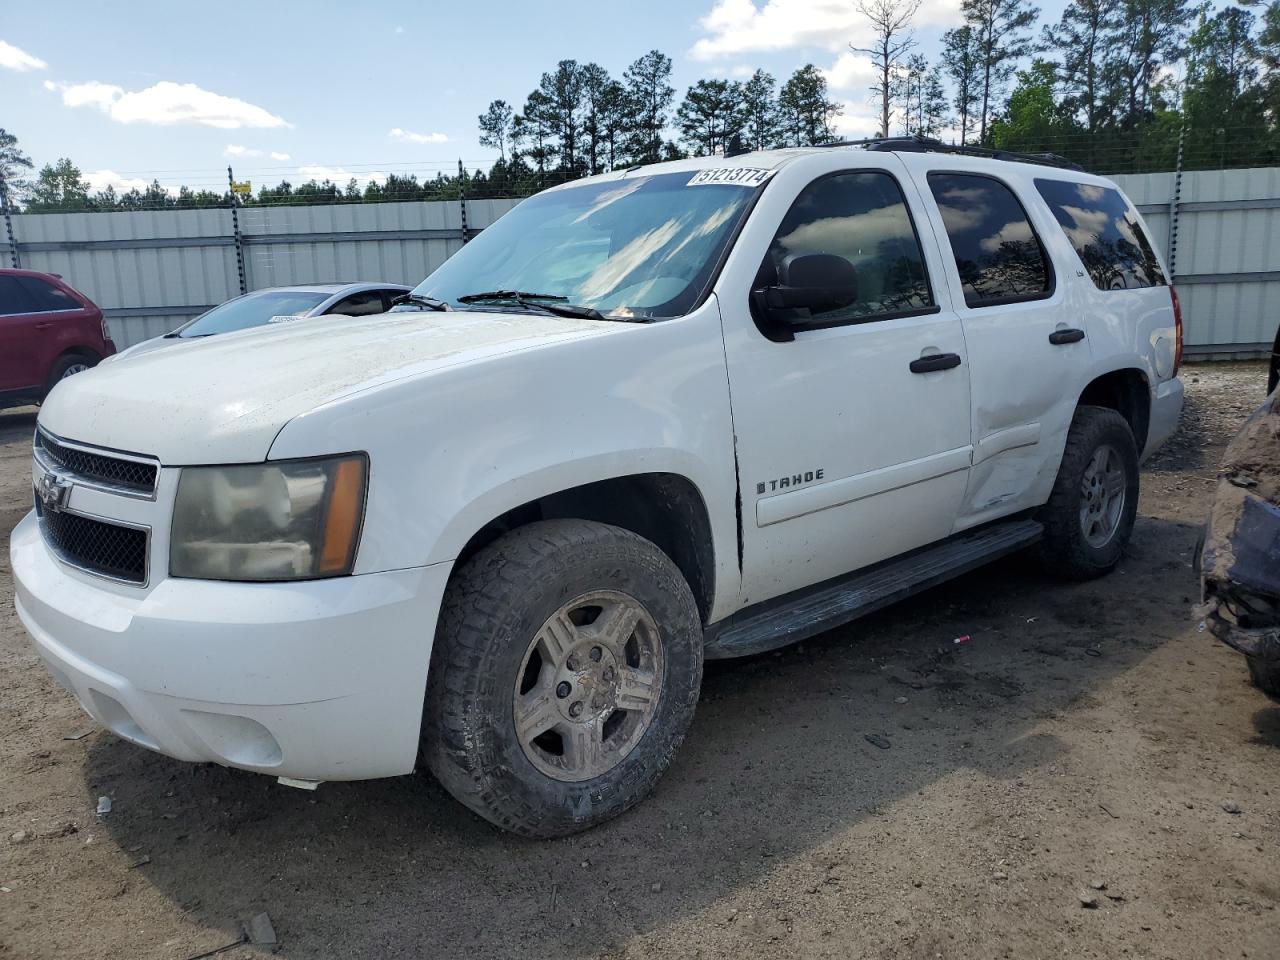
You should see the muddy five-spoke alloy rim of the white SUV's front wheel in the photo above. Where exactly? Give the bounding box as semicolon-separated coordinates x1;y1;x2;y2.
512;590;663;782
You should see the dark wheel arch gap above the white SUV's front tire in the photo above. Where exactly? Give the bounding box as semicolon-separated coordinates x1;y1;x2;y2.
454;472;716;623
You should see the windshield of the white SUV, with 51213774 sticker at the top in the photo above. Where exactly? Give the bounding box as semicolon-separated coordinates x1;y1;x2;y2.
413;170;767;319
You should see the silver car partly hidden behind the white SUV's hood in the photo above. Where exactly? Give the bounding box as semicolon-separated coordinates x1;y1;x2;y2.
119;283;411;357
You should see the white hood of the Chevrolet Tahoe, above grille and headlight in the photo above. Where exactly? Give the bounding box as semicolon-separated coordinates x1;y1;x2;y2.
40;305;611;466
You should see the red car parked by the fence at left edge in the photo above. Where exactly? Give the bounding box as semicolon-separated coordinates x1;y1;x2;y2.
0;270;115;407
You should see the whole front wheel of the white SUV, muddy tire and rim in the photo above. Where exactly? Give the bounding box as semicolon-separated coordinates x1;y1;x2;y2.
421;520;703;837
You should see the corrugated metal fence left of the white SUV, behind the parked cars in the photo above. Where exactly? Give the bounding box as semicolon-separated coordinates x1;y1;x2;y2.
0;200;518;348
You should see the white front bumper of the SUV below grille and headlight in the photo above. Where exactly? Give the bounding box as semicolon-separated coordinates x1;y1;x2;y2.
10;513;452;780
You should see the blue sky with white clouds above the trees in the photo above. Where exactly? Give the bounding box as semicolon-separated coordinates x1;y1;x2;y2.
0;0;1064;195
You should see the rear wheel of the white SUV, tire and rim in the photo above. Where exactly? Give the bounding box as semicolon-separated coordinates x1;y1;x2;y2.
1038;406;1138;580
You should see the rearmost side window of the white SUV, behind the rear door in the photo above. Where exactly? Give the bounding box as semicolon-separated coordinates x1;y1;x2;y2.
1036;179;1165;291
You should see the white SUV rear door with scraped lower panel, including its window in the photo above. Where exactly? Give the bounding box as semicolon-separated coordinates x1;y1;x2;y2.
909;155;1091;530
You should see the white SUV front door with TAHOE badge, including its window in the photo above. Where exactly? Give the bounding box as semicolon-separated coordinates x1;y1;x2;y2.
721;156;972;605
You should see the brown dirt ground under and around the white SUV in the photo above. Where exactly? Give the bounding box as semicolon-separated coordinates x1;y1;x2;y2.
0;364;1280;960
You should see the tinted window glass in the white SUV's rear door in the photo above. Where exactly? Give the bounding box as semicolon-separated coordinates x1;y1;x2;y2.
929;173;1051;307
